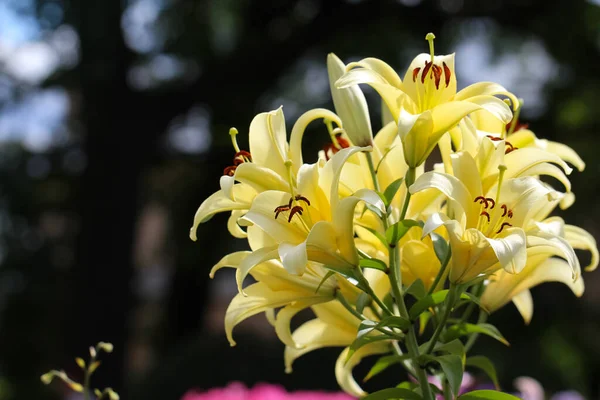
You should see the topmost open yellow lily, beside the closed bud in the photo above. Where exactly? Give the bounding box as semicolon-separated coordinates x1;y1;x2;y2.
337;34;516;168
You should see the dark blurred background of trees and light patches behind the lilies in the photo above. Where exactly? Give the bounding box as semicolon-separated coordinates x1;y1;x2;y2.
0;0;600;400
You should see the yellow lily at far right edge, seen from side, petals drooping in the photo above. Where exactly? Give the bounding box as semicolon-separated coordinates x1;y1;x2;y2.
481;217;598;323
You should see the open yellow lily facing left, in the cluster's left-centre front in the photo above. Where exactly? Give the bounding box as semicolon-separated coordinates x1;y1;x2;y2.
238;147;384;280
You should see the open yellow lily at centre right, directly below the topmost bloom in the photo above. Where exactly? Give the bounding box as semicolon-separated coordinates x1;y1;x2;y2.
410;152;564;283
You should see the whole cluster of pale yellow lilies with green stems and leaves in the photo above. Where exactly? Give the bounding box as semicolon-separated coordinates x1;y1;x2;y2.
190;33;598;400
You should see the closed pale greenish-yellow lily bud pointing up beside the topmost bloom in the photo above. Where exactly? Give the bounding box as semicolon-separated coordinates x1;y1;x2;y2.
327;53;373;147
